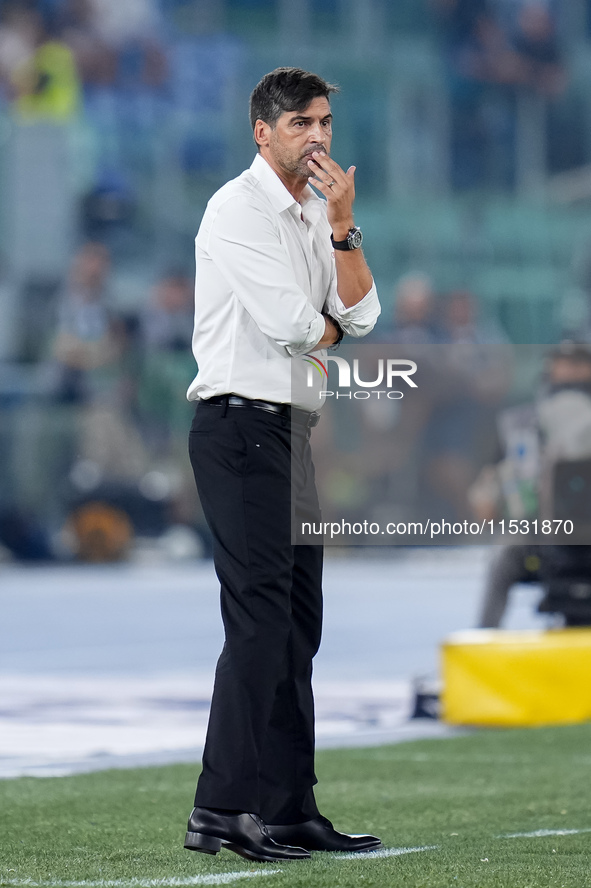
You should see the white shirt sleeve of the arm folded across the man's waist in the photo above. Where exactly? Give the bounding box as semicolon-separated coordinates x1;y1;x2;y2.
198;194;325;354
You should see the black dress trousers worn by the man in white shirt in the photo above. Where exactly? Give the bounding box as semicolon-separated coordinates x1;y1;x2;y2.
189;404;322;823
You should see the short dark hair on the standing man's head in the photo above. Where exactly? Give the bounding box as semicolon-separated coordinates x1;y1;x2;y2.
249;68;339;145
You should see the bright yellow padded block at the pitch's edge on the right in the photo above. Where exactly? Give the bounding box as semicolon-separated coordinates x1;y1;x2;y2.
442;628;591;726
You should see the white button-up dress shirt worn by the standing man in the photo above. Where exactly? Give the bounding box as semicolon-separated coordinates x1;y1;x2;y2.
187;154;380;411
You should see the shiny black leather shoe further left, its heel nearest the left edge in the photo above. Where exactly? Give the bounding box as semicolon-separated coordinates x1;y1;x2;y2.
185;808;310;861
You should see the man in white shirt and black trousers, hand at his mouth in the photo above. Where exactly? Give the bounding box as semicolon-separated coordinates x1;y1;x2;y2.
185;68;380;860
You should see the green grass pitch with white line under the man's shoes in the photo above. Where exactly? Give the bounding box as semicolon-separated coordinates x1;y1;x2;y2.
0;725;591;888
